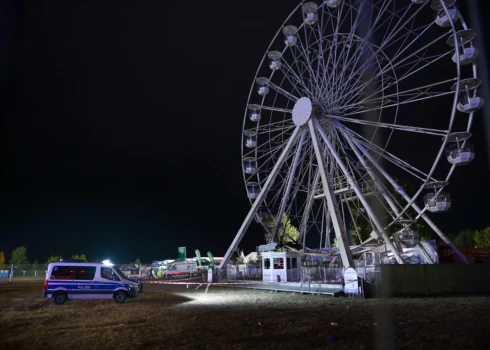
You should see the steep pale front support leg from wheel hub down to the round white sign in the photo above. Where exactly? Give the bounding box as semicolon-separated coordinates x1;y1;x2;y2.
308;119;354;268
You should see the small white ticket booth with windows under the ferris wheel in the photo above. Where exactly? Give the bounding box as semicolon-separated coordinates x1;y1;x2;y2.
261;251;301;282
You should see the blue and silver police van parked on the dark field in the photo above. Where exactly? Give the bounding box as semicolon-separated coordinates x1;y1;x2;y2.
44;261;141;305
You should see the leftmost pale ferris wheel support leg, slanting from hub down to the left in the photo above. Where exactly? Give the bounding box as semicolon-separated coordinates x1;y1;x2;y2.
219;126;300;269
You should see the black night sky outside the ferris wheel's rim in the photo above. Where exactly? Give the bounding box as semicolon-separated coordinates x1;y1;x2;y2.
0;0;490;262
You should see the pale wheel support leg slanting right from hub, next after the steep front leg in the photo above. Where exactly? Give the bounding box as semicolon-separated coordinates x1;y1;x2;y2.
312;121;404;264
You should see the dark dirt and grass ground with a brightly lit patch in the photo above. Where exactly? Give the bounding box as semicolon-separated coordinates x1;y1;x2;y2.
0;282;490;350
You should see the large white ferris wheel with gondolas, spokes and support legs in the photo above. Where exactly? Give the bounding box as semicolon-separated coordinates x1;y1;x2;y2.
222;0;484;267
